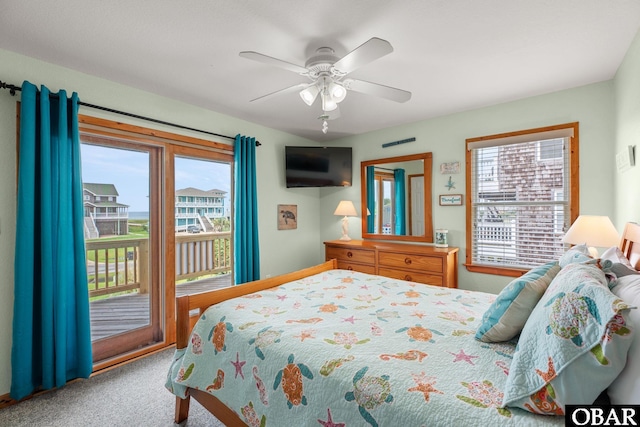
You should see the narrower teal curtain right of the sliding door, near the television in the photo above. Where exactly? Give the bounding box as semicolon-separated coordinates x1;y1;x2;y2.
233;135;260;285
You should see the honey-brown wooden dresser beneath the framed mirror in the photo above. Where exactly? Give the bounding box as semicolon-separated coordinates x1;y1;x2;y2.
324;240;458;288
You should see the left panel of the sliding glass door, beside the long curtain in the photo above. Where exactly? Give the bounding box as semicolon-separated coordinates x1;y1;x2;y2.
81;134;163;361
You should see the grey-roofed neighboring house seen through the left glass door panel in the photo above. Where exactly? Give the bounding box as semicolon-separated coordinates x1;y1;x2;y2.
82;183;129;239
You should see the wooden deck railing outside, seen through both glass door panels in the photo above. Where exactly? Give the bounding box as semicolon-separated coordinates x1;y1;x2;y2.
86;232;232;297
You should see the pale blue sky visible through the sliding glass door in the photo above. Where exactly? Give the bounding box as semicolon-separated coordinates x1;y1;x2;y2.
82;144;231;212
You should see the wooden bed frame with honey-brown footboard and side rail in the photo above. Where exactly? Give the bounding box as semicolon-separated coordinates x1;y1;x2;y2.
175;222;640;427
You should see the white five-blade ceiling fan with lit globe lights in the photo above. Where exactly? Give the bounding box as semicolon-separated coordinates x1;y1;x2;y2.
240;37;411;133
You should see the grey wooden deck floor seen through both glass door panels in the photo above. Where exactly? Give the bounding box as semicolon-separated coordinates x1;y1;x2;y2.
89;274;231;341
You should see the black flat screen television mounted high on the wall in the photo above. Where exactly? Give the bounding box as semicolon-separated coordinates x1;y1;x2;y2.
284;146;352;188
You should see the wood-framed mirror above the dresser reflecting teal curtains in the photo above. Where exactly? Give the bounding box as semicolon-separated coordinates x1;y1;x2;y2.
360;153;433;242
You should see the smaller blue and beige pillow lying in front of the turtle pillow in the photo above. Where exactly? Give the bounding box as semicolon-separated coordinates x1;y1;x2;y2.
476;262;560;342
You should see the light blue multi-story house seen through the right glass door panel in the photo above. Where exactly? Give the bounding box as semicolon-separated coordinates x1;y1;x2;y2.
175;187;228;231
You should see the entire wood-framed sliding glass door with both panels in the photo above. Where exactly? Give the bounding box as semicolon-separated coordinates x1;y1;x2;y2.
80;116;233;370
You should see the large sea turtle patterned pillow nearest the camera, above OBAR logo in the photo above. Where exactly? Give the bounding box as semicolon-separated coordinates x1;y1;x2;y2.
502;263;632;415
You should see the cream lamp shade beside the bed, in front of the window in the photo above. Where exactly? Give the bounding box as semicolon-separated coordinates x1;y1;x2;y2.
562;215;620;248
